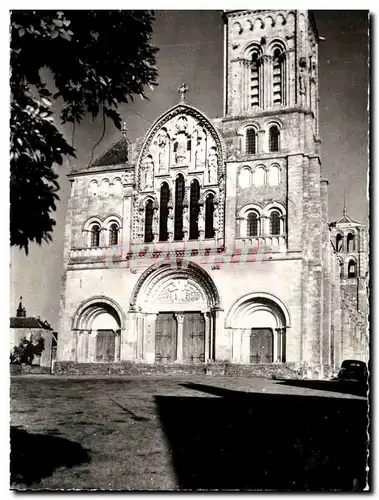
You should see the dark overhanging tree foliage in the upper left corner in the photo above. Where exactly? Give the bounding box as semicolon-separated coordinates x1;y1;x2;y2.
10;10;157;253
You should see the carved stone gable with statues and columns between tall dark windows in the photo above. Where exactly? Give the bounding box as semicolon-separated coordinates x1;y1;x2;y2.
133;105;225;242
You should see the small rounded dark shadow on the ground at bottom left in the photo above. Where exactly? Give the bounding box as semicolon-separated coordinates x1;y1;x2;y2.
10;427;90;488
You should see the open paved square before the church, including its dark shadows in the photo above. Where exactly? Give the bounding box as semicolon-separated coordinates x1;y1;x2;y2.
11;376;367;491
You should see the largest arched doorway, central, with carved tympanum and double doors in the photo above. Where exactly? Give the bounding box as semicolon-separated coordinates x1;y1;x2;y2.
129;261;219;364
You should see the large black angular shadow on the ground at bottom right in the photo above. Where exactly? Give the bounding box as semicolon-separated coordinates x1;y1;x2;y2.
156;383;367;491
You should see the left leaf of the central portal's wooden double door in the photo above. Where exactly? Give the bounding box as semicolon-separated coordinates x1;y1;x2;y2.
155;313;177;363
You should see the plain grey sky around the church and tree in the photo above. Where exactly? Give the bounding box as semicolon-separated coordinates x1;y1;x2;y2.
9;10;369;331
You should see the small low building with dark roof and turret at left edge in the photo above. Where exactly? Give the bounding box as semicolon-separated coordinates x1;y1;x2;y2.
9;297;56;368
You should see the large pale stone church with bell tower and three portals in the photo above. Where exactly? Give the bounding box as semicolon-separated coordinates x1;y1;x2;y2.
56;10;368;376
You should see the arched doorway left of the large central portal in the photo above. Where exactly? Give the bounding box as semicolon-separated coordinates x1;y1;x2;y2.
72;297;125;363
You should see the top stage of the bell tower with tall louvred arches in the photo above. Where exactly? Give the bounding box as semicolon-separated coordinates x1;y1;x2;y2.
224;10;319;147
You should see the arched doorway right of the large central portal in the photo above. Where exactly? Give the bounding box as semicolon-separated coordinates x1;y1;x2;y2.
226;293;290;364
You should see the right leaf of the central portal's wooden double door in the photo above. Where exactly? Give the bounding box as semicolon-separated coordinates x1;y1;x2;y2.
183;312;205;363
